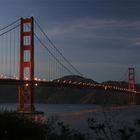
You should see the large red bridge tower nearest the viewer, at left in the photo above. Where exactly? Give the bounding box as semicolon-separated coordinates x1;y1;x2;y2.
18;17;34;112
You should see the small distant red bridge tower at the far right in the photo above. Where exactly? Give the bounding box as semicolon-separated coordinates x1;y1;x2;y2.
128;67;135;104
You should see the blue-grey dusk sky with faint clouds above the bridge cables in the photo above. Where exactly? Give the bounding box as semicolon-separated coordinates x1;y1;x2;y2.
0;0;140;82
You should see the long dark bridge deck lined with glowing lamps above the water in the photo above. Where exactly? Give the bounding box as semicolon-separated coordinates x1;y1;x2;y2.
0;79;137;94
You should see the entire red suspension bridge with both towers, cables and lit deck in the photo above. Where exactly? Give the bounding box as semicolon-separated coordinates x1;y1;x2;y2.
0;17;139;113
